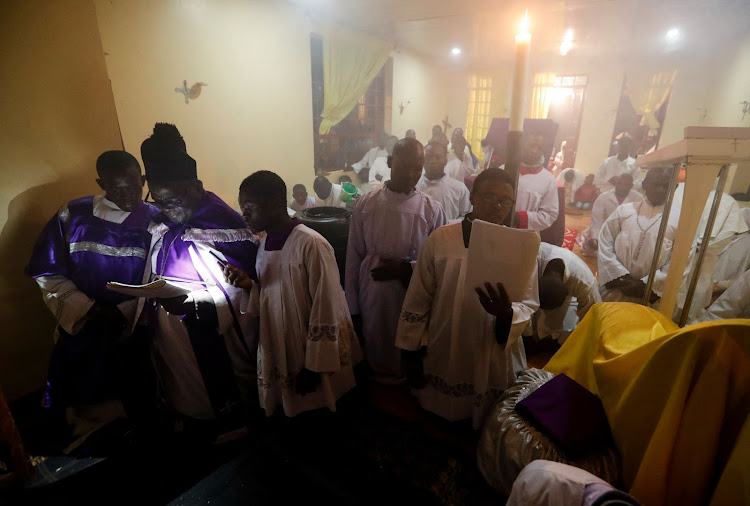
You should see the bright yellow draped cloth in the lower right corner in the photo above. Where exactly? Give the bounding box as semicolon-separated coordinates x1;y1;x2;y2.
545;302;750;506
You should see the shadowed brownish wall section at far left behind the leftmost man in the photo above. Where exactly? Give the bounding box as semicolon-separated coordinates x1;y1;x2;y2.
0;0;121;399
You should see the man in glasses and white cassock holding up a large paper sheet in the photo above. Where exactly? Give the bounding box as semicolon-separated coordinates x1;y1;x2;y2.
396;168;539;428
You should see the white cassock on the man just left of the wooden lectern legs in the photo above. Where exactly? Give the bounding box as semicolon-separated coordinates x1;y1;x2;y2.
599;198;679;304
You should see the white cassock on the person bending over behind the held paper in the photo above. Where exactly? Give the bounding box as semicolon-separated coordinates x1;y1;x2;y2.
534;242;602;343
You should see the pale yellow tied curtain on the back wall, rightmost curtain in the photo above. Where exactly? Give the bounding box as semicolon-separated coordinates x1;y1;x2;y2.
627;68;677;134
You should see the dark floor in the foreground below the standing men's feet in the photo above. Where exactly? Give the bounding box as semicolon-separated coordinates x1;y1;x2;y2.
0;387;516;506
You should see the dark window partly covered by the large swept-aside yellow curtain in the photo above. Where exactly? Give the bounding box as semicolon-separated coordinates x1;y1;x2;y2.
310;35;393;174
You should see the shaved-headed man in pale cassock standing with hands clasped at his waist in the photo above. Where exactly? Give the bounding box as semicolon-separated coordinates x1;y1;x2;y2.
346;138;446;383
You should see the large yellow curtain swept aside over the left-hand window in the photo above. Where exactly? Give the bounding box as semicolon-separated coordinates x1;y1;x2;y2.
320;30;391;134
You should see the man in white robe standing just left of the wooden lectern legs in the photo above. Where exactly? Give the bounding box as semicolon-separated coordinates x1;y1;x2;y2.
599;167;679;303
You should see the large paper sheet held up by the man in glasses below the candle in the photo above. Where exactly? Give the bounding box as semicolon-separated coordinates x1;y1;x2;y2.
464;220;541;302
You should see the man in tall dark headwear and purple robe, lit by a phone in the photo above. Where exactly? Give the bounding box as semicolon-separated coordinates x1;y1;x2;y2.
141;123;258;435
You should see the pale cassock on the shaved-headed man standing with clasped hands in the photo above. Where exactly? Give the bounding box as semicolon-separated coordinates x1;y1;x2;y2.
345;187;445;377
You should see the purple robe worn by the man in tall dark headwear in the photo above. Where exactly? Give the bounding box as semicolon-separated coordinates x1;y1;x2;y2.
143;192;258;419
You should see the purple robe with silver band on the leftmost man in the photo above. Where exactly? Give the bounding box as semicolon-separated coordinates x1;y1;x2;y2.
26;196;158;407
